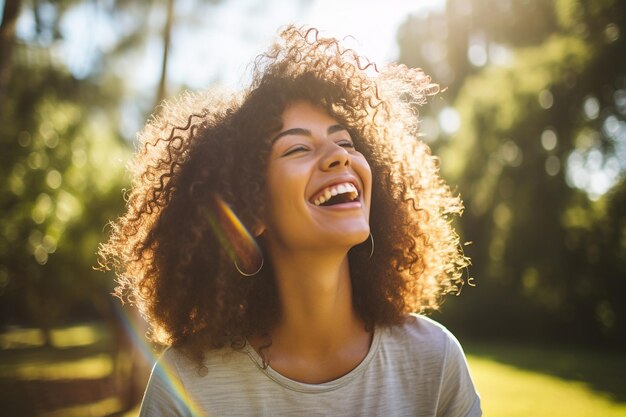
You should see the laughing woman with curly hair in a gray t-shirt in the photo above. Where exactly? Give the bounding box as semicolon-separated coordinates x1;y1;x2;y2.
100;27;481;416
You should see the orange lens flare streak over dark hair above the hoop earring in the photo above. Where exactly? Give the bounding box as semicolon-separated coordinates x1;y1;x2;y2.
207;194;263;275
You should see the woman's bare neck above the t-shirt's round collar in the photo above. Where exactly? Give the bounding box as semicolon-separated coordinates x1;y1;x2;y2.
252;242;371;383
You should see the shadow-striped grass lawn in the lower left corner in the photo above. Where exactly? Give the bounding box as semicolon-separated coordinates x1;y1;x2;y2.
0;323;129;417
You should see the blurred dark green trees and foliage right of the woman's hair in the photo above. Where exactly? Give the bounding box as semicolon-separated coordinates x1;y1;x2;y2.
401;0;626;343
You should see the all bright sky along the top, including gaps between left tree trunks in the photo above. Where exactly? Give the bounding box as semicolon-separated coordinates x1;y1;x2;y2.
14;0;445;94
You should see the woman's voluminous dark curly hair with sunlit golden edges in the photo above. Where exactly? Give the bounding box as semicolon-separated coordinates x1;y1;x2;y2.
99;26;469;359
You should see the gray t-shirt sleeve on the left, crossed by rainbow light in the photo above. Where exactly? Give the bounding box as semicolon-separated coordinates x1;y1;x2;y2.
139;352;192;417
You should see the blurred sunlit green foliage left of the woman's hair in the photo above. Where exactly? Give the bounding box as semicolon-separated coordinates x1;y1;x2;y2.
0;46;129;328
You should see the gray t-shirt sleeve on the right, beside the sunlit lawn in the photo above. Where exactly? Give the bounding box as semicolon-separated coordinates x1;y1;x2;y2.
437;332;482;417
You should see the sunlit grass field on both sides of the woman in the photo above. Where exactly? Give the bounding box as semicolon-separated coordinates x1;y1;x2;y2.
0;324;626;417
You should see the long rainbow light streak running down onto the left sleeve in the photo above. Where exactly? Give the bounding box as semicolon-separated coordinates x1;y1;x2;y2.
114;304;209;417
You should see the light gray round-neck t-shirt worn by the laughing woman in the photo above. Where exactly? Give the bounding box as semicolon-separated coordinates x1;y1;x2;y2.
140;315;482;417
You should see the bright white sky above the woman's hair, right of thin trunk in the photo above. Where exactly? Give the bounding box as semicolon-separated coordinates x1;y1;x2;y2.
155;0;444;91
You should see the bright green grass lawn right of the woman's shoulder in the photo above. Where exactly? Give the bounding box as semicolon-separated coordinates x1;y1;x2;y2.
465;342;626;417
